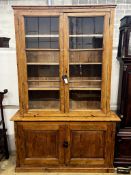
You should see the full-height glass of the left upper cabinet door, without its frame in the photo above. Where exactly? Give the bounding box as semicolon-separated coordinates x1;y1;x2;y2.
25;16;60;110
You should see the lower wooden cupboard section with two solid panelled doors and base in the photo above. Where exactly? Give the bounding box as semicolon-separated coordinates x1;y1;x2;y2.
15;121;115;172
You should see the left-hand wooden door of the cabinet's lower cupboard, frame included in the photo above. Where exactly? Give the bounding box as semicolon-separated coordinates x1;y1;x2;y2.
16;122;65;167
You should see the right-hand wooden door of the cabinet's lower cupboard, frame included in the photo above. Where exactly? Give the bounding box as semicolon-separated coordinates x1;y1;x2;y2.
66;123;114;167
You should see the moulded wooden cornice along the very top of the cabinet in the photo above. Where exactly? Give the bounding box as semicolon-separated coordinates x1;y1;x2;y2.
12;4;116;10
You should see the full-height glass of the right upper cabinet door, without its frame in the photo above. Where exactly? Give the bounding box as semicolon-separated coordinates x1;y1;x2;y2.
69;16;104;110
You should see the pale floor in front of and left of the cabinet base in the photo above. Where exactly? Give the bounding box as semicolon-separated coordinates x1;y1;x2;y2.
0;155;125;175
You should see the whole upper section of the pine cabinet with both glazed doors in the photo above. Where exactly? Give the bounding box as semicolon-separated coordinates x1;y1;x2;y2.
14;6;114;115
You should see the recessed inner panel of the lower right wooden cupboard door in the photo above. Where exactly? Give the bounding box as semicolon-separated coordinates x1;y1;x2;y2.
70;131;105;158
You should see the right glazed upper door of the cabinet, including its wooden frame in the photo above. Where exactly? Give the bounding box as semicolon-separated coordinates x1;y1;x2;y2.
64;13;109;112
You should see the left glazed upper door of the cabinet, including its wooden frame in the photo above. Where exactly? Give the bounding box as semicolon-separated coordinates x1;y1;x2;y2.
19;12;64;113
